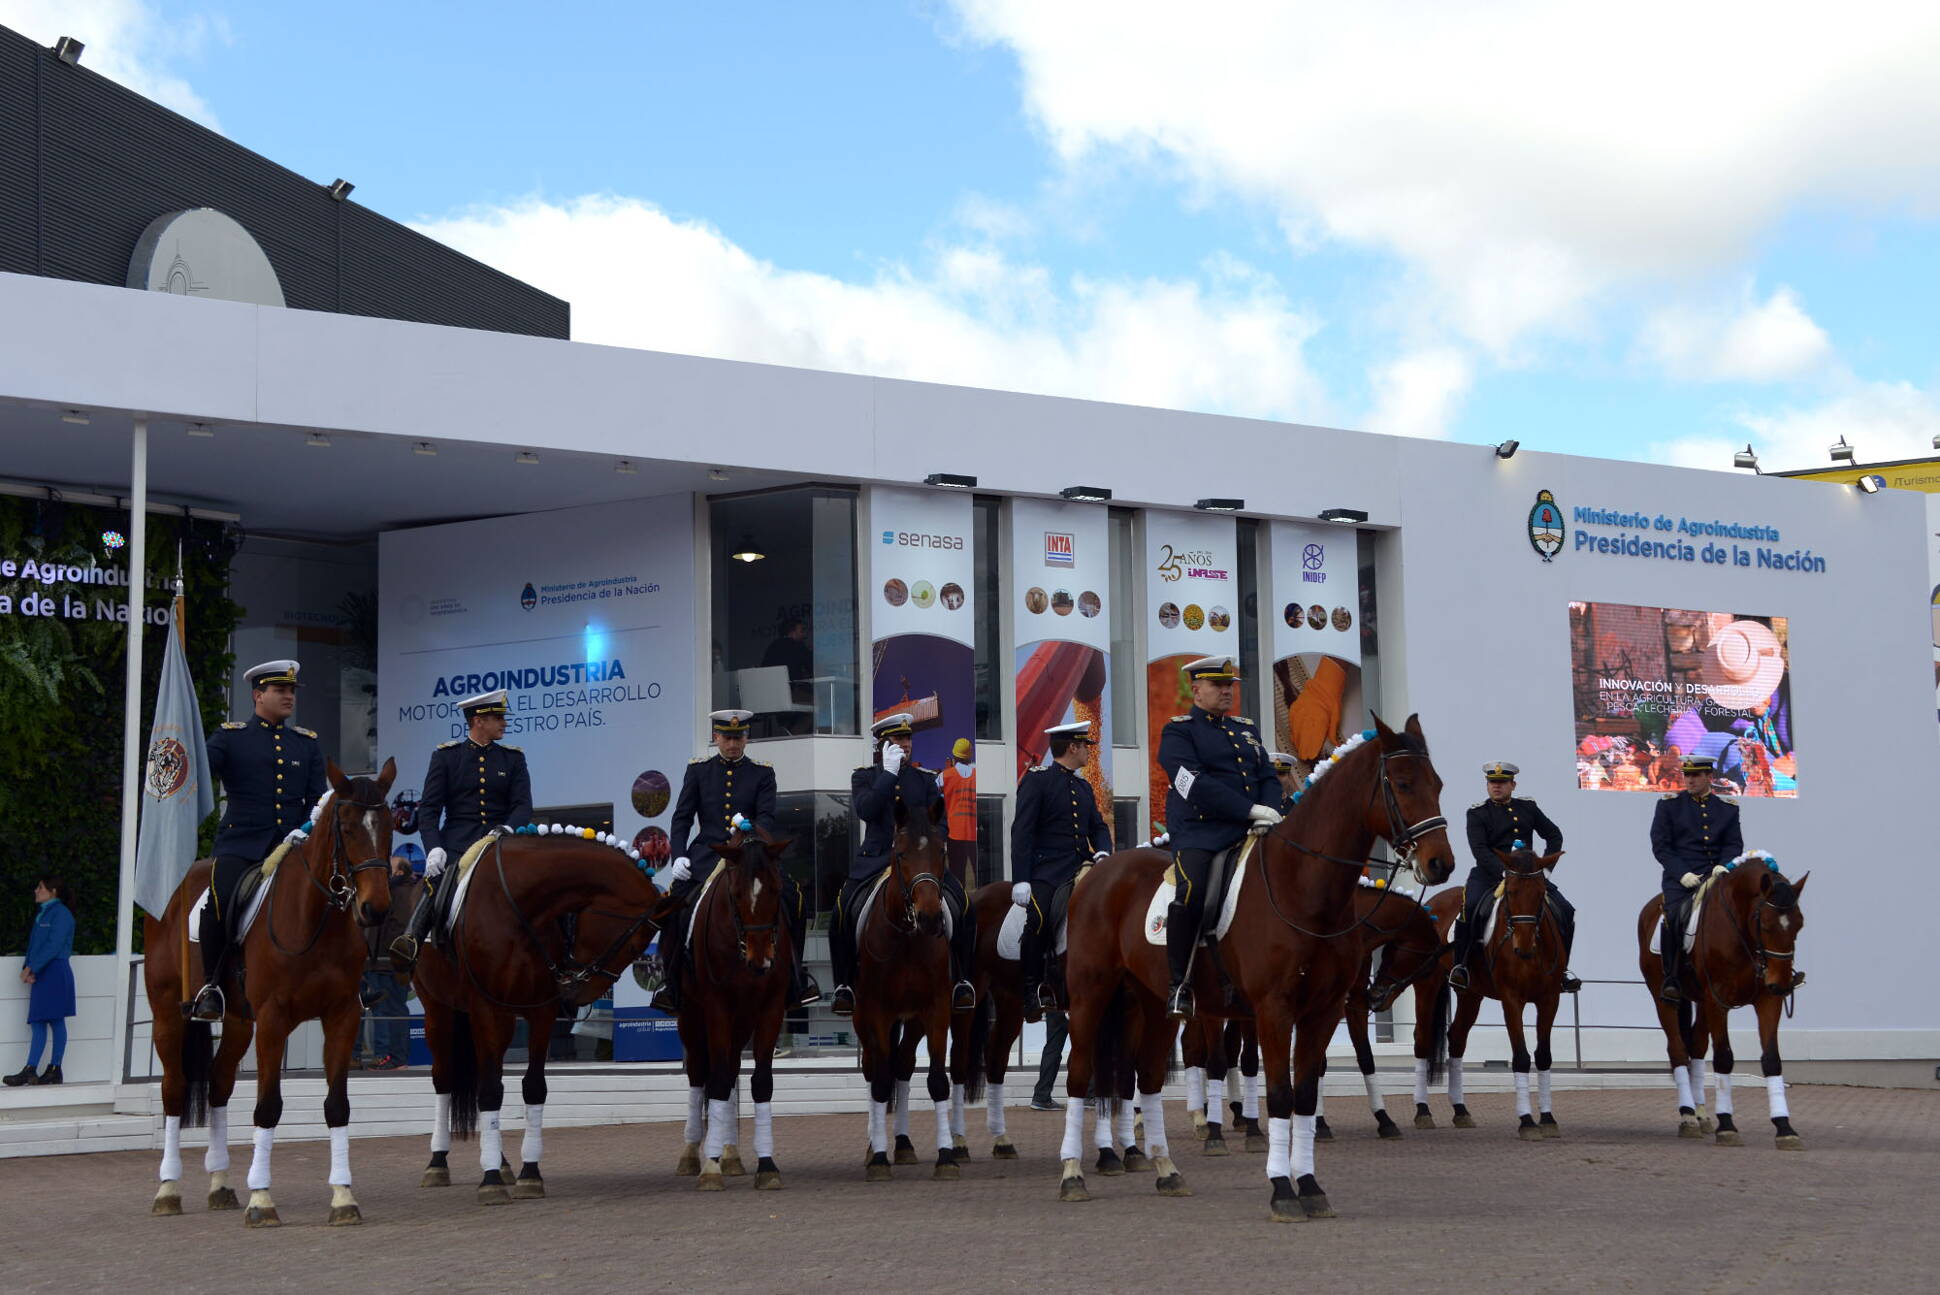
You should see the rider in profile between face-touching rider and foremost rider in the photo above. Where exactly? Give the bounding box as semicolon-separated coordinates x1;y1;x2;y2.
1011;721;1112;1012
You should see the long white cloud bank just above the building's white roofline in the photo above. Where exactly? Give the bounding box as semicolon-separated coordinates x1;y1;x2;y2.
415;196;1327;421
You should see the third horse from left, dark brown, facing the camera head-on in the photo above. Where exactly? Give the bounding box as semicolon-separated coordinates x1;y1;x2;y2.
675;830;795;1192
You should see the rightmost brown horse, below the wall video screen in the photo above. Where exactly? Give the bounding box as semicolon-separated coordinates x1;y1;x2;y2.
1637;855;1812;1152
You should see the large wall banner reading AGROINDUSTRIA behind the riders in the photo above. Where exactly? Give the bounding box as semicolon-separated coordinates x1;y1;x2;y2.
378;494;704;863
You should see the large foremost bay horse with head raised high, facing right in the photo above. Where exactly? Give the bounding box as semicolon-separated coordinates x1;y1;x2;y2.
1059;715;1455;1221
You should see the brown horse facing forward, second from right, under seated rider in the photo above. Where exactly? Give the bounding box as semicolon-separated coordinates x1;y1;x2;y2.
1416;847;1566;1142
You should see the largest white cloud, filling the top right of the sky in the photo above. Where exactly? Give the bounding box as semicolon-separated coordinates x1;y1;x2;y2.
954;0;1940;357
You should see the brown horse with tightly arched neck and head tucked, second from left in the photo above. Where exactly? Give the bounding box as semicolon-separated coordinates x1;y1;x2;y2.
411;832;669;1206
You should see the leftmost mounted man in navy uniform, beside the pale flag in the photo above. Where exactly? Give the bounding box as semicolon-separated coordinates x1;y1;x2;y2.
190;661;326;1022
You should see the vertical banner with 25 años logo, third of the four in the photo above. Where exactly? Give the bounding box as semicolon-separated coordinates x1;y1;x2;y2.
1145;512;1240;822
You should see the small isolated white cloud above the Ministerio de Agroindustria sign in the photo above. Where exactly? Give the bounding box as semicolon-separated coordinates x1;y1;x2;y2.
1637;287;1831;382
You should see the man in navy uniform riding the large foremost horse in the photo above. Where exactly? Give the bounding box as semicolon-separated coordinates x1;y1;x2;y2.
1158;657;1284;1020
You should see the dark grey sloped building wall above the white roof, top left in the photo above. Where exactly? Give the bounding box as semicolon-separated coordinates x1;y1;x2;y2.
0;27;570;337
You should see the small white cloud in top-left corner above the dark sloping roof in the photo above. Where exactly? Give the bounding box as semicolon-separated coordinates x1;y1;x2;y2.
0;0;229;130
